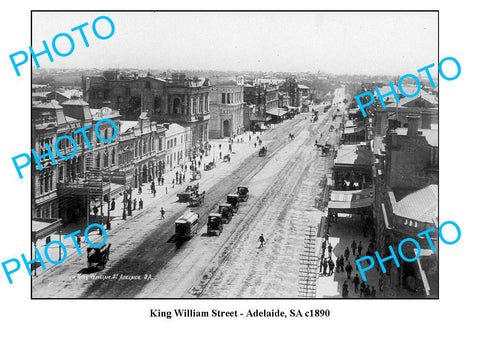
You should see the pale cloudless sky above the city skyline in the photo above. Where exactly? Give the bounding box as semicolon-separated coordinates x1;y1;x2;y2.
32;12;438;75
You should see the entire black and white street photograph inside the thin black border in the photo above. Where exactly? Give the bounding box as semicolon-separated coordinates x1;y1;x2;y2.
32;11;439;299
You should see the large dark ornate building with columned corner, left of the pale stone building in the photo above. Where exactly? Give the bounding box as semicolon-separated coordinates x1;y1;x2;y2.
82;71;210;158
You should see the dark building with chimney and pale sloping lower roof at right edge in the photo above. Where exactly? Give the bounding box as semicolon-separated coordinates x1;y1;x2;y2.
373;115;438;296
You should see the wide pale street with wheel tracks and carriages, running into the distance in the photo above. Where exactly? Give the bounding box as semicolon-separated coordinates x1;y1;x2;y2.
32;88;344;298
